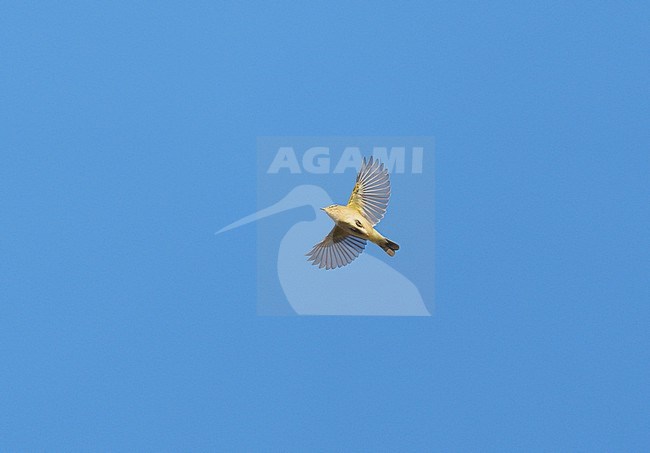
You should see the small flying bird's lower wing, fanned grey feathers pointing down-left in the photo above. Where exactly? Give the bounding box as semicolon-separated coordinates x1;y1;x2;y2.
307;226;366;269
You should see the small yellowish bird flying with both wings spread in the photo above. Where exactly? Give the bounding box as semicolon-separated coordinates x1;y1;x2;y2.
307;157;399;269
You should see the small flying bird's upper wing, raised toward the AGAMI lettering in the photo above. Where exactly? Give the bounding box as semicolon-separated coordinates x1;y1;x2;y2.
348;157;390;226
